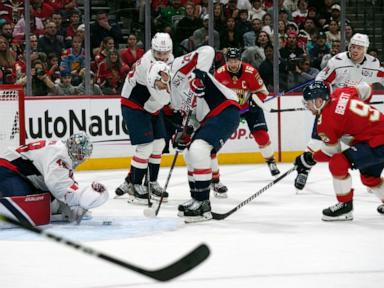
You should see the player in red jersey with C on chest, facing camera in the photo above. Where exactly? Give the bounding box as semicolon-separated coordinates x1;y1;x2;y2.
215;48;280;176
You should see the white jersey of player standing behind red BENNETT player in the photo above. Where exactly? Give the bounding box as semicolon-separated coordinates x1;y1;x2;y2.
316;52;383;89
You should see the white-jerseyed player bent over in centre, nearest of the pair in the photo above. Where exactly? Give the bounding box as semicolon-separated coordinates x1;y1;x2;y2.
153;46;240;223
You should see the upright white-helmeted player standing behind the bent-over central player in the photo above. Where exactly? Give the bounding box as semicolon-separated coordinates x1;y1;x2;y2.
116;33;173;204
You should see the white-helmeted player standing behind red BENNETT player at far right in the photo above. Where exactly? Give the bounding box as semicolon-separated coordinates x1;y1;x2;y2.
295;33;384;190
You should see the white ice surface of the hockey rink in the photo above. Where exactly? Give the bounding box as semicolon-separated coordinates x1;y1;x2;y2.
0;164;384;288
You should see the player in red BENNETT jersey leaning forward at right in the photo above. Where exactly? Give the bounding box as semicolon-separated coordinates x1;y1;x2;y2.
295;81;384;221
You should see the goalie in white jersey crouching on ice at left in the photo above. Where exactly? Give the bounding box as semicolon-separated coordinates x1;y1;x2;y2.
0;132;108;226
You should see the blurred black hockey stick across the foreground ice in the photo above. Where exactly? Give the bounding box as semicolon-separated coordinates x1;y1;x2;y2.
0;215;210;281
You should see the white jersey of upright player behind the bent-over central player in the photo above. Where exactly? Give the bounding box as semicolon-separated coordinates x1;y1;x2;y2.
121;50;174;113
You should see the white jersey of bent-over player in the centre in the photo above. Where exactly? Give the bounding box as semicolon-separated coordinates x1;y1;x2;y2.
171;46;238;122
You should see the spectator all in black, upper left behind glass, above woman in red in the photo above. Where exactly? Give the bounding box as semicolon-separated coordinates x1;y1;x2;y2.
90;11;123;51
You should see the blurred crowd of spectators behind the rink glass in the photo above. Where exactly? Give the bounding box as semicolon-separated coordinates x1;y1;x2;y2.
0;0;379;95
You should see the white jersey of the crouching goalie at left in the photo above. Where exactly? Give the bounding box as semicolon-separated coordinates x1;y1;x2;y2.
1;140;108;209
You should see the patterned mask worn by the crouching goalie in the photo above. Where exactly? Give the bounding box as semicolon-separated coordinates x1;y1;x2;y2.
65;131;93;168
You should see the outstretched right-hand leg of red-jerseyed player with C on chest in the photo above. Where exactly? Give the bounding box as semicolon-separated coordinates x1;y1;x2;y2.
244;106;280;176
